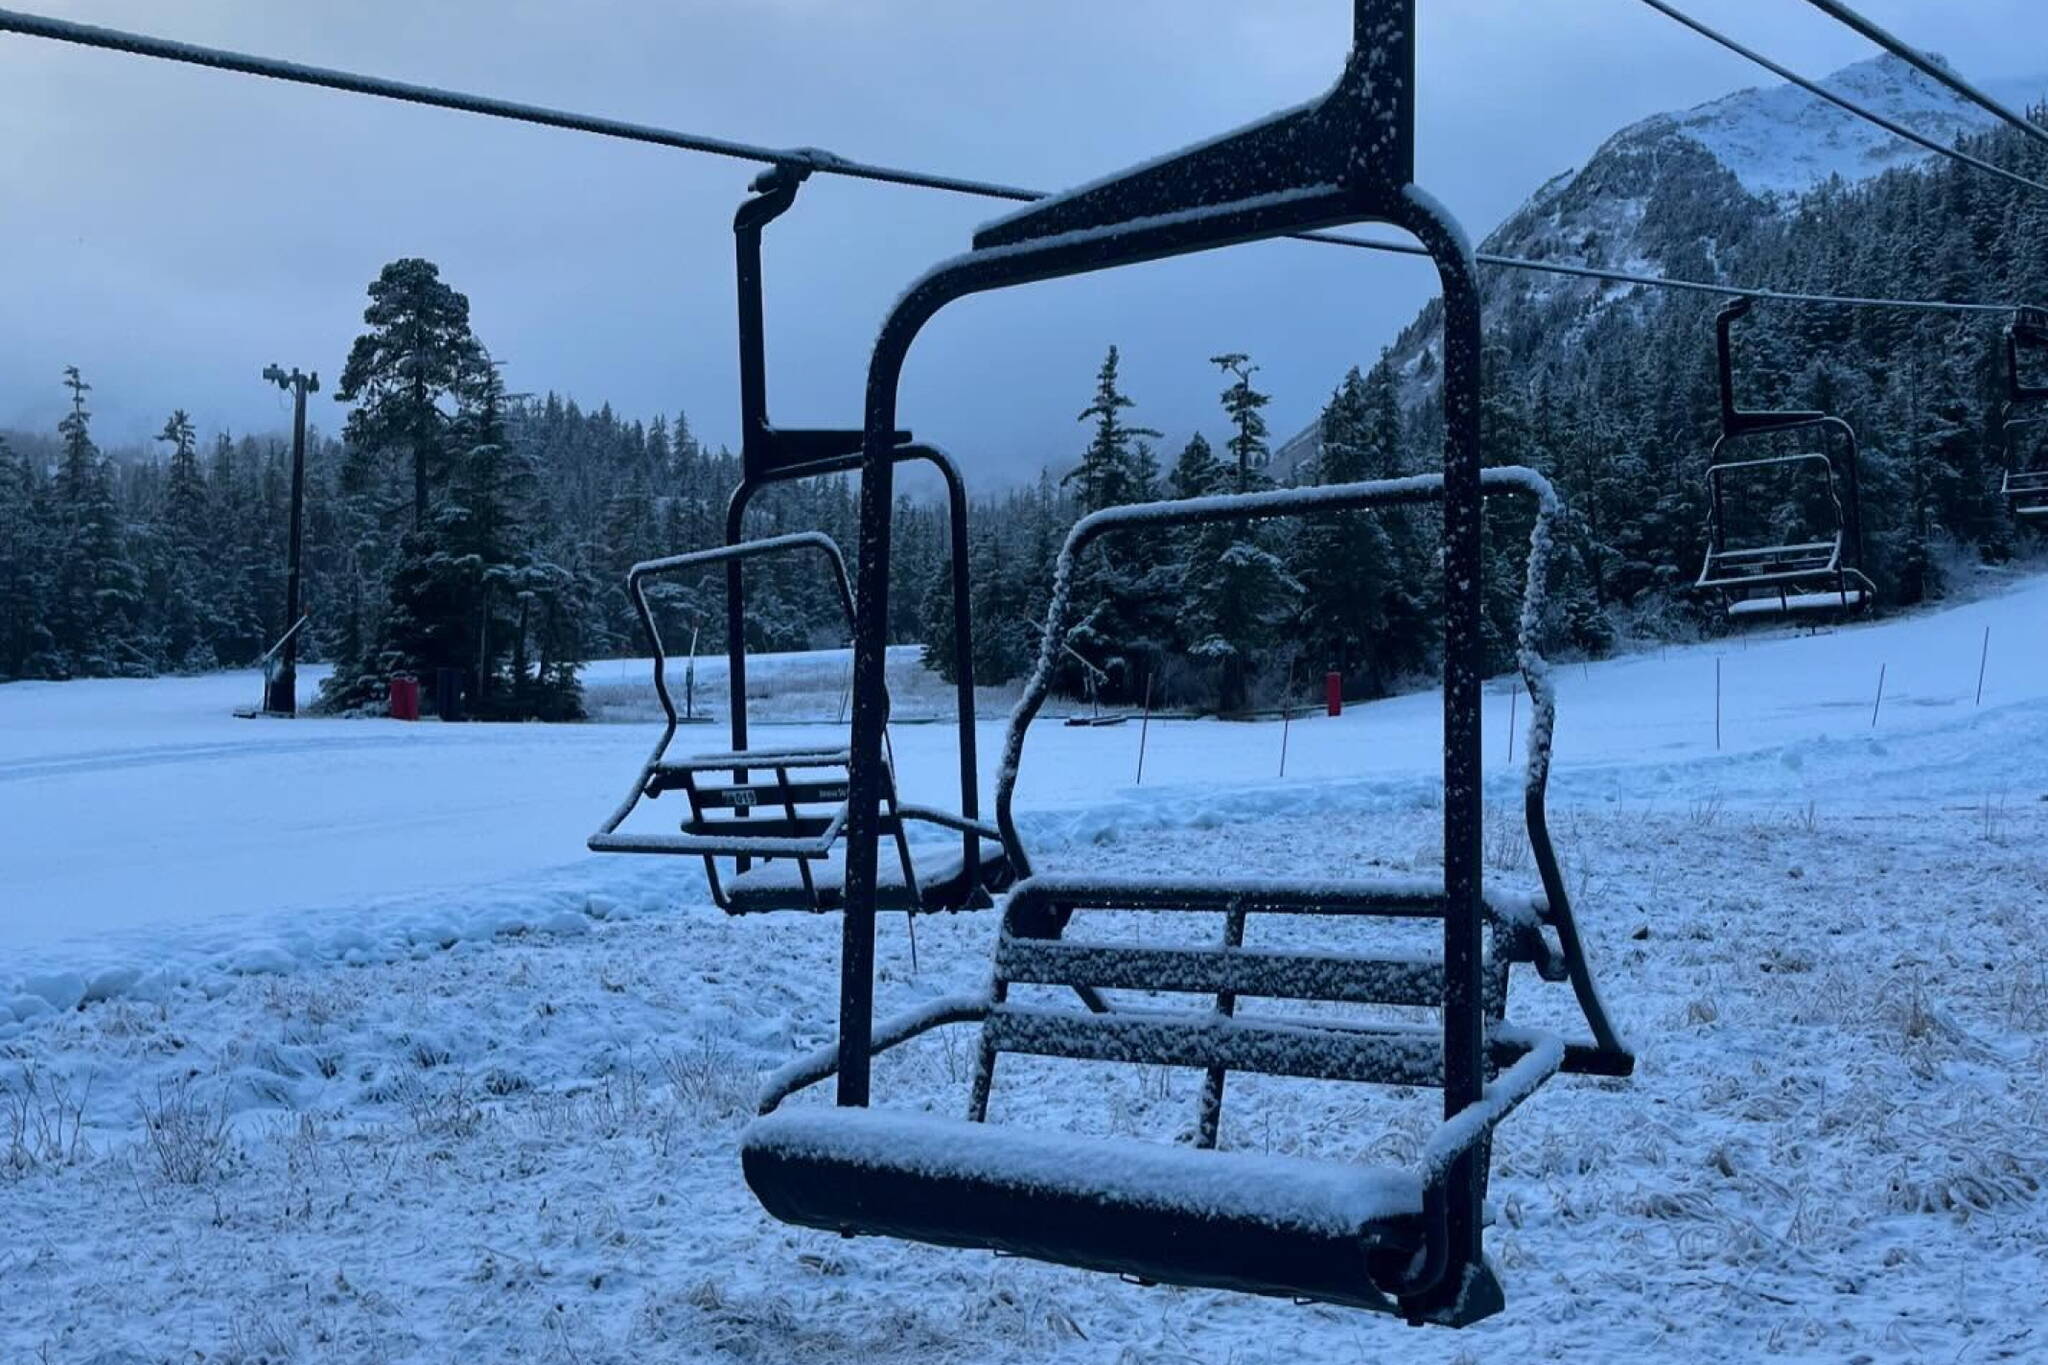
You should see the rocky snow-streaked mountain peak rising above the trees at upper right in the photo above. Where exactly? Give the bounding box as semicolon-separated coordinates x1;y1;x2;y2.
1274;55;2048;479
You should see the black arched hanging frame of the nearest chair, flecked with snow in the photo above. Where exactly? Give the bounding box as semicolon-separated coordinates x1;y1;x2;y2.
838;0;1487;1309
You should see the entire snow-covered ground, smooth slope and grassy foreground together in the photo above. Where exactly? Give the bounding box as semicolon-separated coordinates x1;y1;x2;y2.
0;579;2048;1365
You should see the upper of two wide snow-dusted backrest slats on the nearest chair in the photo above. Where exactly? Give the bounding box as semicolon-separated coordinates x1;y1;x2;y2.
995;935;1444;1005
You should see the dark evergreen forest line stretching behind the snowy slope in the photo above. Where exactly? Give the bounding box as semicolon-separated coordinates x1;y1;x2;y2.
0;113;2048;716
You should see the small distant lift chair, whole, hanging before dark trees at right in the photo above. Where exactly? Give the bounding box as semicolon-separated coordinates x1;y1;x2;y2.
1694;299;1876;620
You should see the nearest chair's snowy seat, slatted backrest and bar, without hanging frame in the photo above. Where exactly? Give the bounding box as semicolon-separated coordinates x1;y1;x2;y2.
743;469;1632;1326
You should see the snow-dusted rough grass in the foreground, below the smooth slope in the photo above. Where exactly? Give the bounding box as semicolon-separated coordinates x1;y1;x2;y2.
0;804;2048;1363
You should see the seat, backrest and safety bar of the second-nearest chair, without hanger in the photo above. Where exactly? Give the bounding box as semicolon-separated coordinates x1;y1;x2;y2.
588;532;1010;915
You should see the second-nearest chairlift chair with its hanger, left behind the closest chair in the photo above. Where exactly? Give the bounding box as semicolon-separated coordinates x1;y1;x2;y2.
590;162;1012;915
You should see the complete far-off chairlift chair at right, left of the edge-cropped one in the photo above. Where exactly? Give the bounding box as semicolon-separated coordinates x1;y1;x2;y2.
1694;299;1876;622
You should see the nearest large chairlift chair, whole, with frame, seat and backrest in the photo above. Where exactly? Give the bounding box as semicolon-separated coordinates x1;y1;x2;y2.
743;0;1632;1326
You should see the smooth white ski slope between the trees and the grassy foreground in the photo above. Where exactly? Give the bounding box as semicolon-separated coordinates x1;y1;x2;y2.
0;577;2048;970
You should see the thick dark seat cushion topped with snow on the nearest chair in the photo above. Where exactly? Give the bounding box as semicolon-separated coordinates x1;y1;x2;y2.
741;1107;1449;1312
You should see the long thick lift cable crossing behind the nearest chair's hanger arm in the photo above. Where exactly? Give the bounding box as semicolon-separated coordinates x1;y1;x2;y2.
0;8;2013;313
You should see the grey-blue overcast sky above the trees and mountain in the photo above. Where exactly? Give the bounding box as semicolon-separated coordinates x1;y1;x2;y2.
0;0;2048;481
